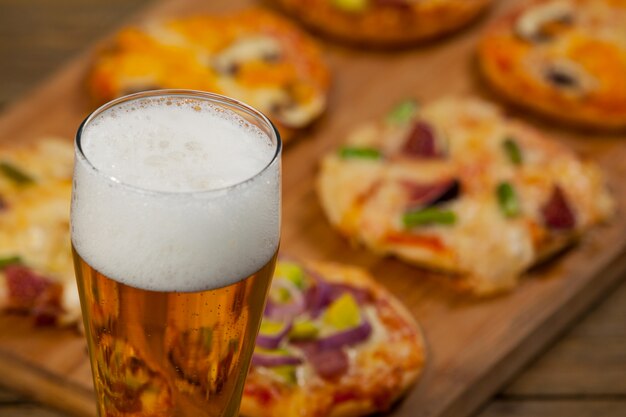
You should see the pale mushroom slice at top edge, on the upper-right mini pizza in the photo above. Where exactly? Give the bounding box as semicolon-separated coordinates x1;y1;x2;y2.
515;0;575;42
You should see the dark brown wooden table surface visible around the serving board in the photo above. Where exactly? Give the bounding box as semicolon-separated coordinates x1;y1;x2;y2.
0;0;626;417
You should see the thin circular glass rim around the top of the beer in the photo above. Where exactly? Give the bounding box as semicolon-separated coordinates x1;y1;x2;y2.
74;89;282;196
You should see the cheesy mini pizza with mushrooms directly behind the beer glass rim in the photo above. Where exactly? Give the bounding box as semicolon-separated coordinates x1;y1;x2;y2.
87;9;329;140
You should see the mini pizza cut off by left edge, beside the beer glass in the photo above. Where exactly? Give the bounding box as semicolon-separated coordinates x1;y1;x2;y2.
0;139;80;325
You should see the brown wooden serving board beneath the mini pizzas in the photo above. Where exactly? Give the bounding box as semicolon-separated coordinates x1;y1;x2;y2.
0;0;626;417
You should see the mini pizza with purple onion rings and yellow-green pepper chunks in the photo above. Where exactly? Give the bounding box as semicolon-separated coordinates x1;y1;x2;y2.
241;260;424;417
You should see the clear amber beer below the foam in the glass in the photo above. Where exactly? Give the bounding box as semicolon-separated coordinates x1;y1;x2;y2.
74;251;274;416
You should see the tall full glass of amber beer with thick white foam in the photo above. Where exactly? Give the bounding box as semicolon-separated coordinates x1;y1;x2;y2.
71;90;281;417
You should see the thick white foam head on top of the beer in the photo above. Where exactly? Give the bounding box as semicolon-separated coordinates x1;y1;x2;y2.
71;97;280;292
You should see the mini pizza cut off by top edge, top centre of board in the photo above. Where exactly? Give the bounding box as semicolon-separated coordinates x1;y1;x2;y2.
274;0;491;46
